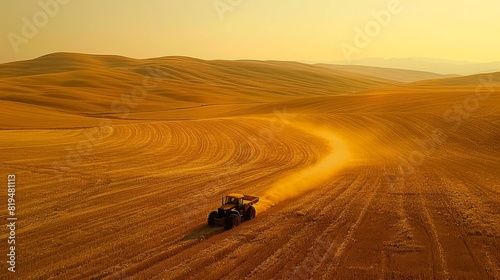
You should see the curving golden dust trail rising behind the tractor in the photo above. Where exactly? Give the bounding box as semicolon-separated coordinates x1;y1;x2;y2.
256;124;351;212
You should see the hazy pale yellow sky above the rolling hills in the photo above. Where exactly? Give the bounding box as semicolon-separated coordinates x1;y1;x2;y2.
0;0;500;62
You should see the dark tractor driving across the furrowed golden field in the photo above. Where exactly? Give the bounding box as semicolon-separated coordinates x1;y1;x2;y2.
208;193;259;230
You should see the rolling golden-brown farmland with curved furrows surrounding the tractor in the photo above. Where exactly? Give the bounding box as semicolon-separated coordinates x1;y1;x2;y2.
0;53;500;279
